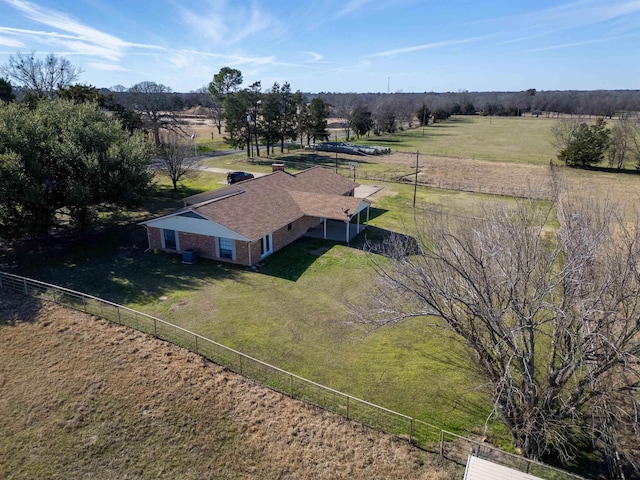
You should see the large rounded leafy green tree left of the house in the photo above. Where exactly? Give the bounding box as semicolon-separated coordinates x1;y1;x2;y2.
0;99;153;240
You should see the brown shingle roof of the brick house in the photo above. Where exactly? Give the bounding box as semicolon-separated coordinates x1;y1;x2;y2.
191;167;361;240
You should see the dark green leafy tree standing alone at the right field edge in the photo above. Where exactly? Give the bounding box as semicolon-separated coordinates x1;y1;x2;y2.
558;118;609;168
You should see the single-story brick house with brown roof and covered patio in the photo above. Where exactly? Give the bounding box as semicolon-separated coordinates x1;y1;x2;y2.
140;164;371;266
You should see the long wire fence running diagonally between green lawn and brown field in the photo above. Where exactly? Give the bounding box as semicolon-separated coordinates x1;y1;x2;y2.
0;272;583;480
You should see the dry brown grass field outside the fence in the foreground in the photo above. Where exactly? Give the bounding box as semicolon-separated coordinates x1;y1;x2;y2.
0;292;461;479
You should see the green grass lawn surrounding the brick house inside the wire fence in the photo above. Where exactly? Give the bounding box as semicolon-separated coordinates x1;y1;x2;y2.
6;173;516;444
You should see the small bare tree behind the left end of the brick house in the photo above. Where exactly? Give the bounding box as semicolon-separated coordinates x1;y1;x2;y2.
158;132;199;190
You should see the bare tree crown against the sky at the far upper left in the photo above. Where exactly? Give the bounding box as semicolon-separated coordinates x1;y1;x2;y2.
0;52;82;97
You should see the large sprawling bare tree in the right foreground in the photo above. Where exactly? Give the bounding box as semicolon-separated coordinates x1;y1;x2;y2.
357;189;640;474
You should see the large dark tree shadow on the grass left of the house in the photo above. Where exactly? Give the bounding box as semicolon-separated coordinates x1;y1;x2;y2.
3;225;242;305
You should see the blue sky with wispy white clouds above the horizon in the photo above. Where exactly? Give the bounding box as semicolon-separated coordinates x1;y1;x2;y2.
0;0;640;92
